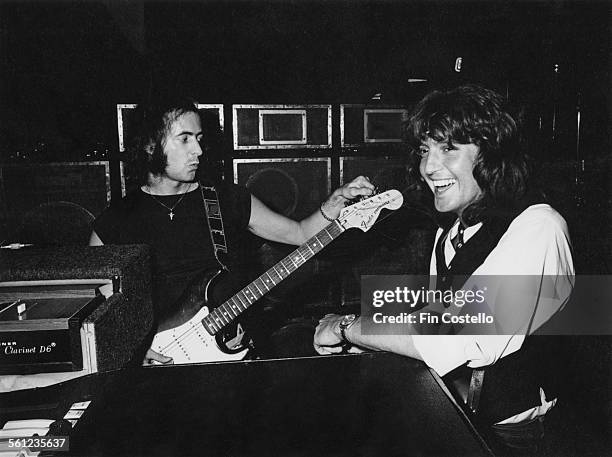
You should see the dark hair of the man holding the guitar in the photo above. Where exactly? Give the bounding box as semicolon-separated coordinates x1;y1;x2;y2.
128;96;199;185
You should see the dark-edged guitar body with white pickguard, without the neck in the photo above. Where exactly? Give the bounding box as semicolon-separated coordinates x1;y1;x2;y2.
151;270;248;364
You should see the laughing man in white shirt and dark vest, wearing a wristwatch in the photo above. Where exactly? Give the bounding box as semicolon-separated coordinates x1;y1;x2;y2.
314;85;574;455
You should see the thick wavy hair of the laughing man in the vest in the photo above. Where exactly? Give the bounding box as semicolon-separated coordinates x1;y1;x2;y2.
404;85;530;225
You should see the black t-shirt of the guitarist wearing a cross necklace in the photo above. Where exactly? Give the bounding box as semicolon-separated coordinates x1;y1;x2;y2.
93;181;251;314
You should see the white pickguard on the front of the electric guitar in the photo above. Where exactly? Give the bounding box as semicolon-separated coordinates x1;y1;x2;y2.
151;306;247;364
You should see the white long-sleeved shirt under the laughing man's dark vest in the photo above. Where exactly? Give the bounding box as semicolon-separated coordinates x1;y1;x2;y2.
413;204;574;422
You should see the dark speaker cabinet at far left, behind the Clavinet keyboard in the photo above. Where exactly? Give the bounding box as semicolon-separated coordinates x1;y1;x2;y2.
0;161;115;245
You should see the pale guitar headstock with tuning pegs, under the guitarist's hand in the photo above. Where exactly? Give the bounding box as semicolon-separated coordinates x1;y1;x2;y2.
338;189;404;232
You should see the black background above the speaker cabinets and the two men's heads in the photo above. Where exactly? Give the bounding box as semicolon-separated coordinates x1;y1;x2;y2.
0;0;610;159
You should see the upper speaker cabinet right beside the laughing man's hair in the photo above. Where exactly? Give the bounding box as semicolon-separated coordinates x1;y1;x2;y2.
340;105;408;147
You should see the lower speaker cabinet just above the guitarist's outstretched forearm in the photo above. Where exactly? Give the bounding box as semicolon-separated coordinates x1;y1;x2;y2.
233;157;331;220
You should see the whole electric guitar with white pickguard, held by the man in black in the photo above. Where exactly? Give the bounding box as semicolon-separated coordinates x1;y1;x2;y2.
151;190;403;364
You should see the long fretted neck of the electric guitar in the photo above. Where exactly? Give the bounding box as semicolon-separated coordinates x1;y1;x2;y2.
202;221;345;336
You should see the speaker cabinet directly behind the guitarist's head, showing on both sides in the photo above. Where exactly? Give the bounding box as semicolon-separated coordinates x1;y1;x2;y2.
117;103;225;152
